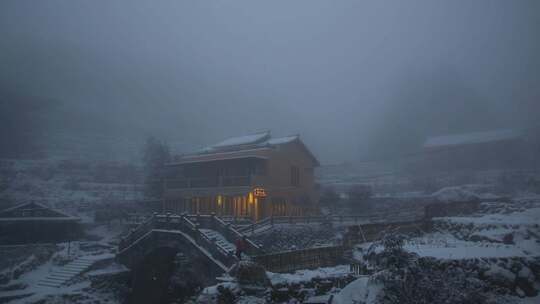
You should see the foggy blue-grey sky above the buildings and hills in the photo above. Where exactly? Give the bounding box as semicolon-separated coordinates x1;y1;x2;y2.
0;0;540;163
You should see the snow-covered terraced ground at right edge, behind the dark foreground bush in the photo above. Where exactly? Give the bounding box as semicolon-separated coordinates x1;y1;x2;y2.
356;196;540;259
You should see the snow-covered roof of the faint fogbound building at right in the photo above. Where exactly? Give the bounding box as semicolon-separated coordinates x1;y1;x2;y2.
424;129;521;148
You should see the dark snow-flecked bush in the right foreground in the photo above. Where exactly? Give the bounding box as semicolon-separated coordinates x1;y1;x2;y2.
365;236;487;304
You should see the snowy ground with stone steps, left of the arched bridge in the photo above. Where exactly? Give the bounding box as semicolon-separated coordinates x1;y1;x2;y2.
0;225;126;303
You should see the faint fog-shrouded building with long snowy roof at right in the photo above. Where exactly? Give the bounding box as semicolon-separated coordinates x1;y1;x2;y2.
422;129;540;171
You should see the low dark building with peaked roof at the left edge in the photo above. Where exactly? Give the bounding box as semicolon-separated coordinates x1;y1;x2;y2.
0;202;82;245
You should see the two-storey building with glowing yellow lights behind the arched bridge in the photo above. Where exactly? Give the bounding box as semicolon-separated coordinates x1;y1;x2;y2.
163;132;319;220
